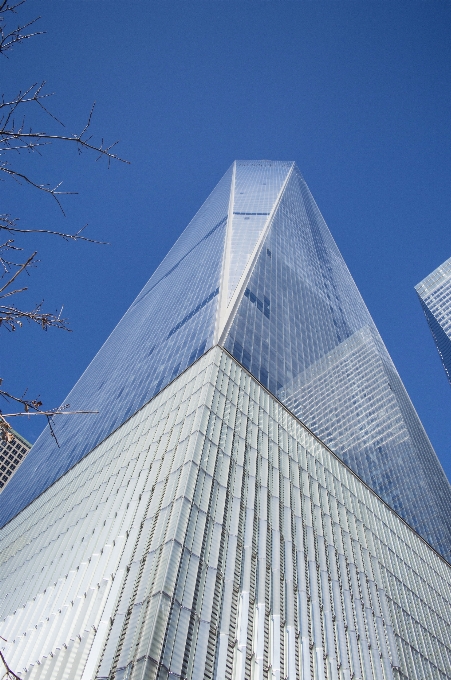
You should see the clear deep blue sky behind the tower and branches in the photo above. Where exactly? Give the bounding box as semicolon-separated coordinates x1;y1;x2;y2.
0;0;451;484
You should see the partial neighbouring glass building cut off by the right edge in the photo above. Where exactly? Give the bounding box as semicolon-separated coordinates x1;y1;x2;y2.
415;257;451;383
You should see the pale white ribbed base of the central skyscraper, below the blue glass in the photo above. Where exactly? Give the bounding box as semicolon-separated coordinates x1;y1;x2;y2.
0;347;451;680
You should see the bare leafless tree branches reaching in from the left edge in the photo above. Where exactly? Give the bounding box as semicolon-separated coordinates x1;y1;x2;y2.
0;0;123;488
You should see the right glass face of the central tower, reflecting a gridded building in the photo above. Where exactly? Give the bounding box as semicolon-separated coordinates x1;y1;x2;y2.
224;169;451;560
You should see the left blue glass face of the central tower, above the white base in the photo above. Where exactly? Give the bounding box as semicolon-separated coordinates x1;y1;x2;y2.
0;169;232;526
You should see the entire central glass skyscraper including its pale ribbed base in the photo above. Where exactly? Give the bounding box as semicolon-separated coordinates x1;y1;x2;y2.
0;161;451;680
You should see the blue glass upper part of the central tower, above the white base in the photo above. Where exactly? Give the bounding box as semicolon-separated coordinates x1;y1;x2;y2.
0;161;451;558
